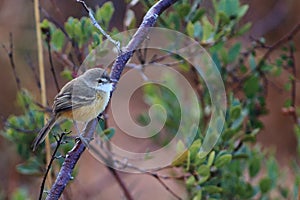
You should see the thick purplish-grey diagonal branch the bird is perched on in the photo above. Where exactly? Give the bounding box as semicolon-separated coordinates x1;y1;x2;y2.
47;0;177;200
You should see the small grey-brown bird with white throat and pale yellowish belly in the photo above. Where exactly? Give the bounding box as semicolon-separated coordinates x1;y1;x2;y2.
33;68;117;151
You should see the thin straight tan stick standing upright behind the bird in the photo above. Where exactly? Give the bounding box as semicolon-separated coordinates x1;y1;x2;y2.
34;0;52;188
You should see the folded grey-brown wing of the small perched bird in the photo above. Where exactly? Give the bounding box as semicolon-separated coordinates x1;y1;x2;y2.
53;79;96;113
